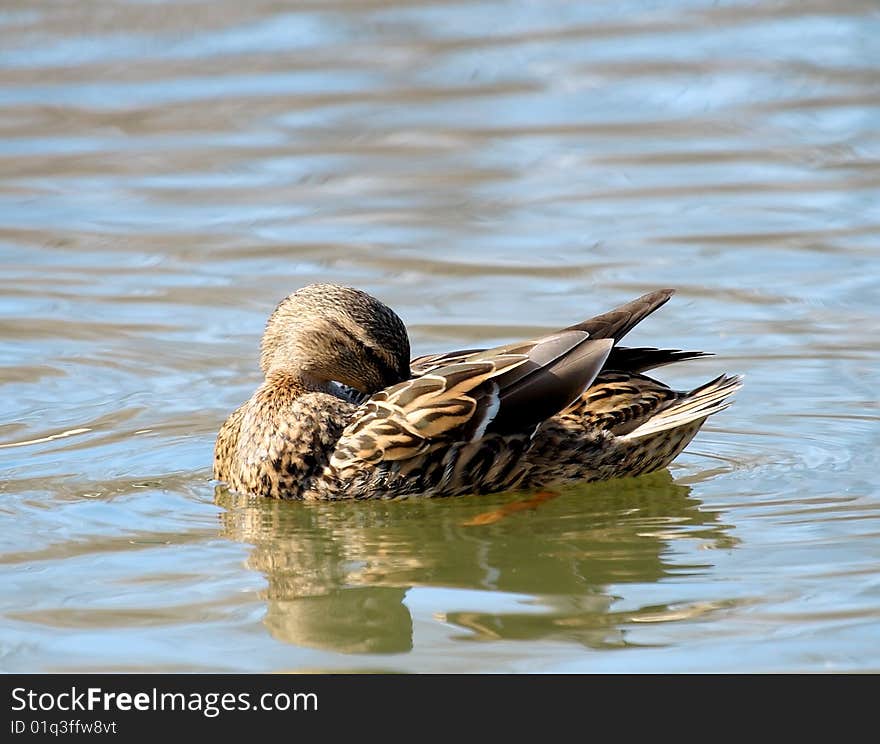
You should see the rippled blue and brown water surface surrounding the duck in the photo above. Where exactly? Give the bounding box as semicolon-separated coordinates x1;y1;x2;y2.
0;0;880;672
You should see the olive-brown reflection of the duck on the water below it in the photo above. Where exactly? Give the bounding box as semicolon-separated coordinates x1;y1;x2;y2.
216;471;733;654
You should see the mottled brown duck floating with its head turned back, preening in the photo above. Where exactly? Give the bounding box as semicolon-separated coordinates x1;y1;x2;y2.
214;283;742;501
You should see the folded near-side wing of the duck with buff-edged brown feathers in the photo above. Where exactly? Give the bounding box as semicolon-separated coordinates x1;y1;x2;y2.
330;331;613;469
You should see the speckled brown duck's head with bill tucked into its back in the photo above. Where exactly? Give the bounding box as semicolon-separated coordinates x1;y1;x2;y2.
260;284;410;393
